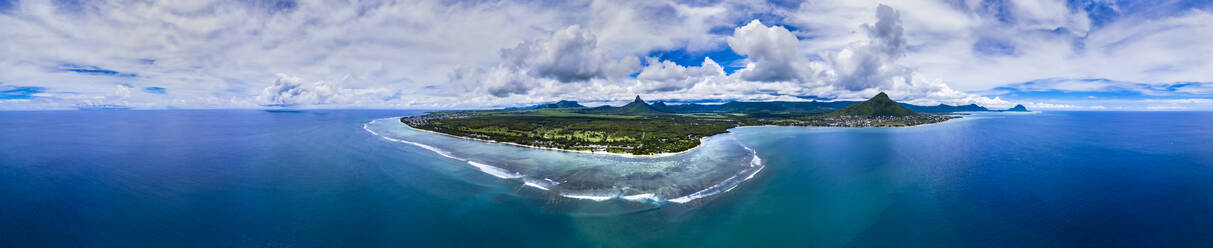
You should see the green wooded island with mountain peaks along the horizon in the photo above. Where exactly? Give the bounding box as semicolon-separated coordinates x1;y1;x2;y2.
400;92;1027;156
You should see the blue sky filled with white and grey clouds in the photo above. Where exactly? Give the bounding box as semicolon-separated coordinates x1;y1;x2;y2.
0;0;1213;111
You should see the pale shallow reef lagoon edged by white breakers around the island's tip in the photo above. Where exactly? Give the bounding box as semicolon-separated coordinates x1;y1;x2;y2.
363;118;763;204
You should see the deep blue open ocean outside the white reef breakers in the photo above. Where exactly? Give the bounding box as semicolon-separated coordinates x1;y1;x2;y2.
0;111;1213;247
